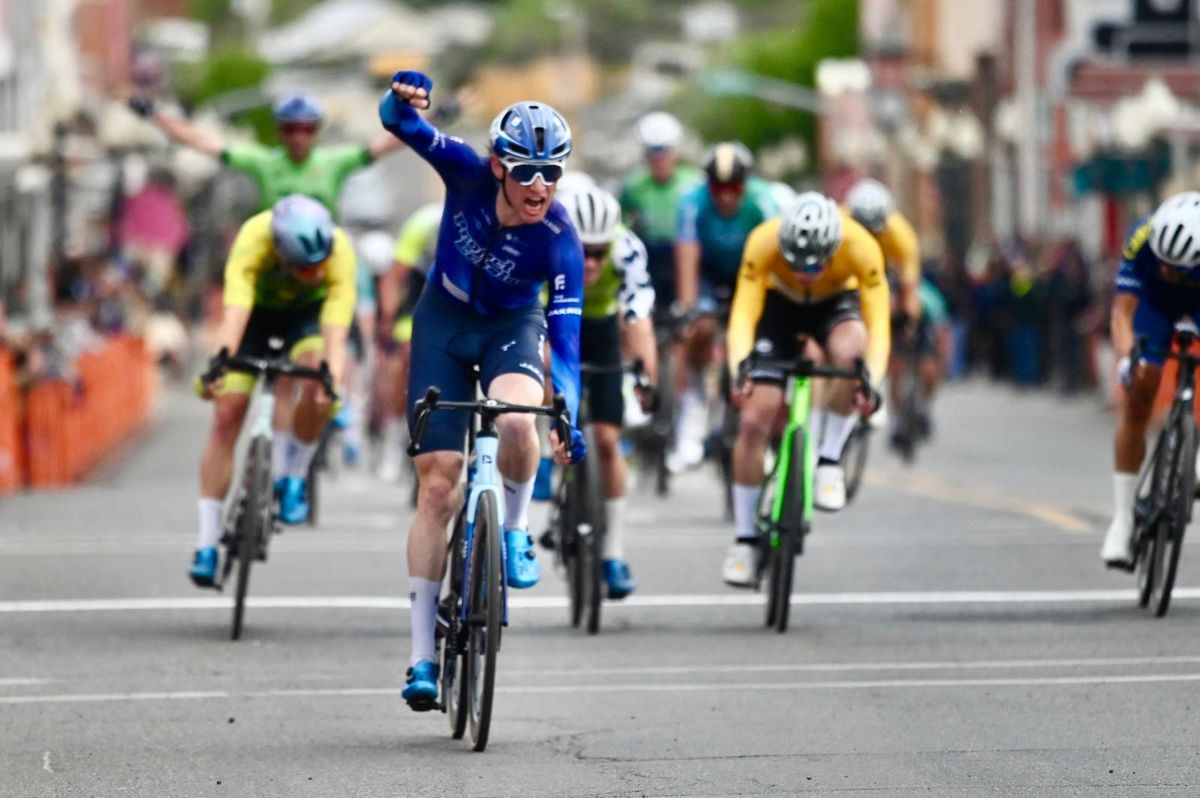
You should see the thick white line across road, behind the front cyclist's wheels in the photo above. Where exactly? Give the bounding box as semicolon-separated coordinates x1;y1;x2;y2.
0;588;1200;614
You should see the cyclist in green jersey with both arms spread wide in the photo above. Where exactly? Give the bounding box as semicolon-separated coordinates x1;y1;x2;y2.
130;94;403;216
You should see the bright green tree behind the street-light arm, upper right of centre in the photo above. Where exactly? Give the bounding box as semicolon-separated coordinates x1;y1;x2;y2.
676;0;858;172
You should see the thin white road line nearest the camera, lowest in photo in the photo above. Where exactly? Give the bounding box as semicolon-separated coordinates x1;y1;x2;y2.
7;673;1200;706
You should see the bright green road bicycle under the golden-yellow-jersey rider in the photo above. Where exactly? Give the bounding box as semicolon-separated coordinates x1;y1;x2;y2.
743;341;878;632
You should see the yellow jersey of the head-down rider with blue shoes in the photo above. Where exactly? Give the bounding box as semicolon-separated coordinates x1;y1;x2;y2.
224;210;358;328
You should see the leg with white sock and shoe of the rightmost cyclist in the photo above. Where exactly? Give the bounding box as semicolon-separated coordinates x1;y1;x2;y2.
1100;296;1180;564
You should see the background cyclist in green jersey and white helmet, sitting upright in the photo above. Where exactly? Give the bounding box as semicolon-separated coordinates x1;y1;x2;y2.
620;112;704;311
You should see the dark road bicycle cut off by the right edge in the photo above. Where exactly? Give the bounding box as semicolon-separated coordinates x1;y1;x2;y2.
1130;322;1200;618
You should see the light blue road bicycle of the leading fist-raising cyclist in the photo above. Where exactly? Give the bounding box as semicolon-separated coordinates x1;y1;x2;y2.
408;388;571;751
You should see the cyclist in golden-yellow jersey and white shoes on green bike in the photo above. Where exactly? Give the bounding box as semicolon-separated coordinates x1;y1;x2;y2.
721;191;892;587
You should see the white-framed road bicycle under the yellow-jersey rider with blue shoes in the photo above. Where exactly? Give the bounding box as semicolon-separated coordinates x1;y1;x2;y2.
204;338;337;640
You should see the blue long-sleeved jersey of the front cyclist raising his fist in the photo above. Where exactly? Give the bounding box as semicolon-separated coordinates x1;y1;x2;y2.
379;91;583;420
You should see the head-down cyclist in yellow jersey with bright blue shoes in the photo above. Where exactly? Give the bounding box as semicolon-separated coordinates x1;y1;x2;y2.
191;194;355;587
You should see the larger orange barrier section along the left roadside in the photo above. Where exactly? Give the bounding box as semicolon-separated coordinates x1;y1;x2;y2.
25;337;155;487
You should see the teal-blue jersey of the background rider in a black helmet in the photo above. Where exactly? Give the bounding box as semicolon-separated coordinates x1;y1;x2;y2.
676;178;779;287
